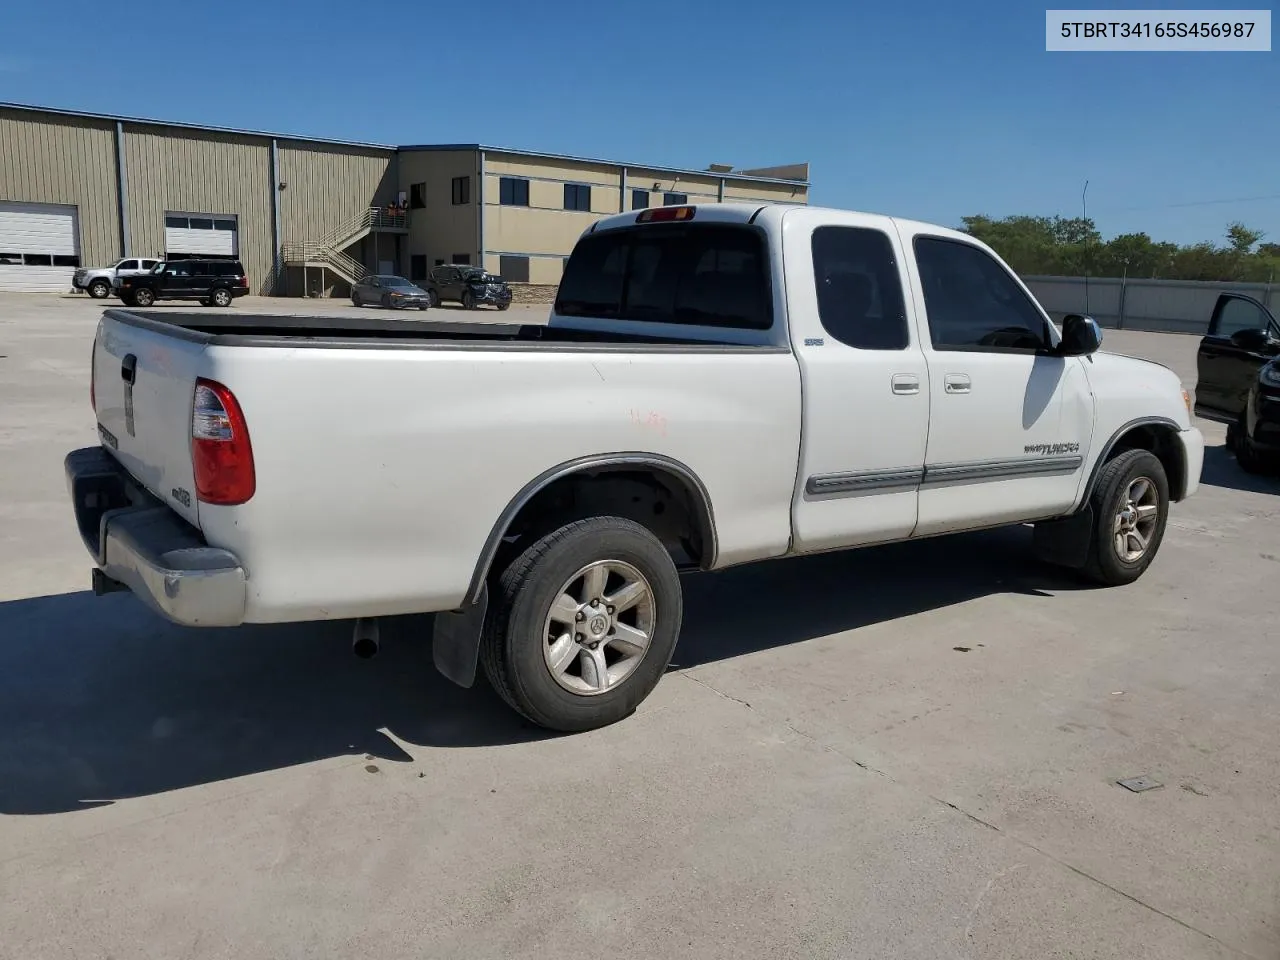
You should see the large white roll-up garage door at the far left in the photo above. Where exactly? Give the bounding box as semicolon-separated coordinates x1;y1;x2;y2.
0;200;79;293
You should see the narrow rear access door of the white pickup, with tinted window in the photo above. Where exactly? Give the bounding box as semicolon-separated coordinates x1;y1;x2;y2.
783;209;929;552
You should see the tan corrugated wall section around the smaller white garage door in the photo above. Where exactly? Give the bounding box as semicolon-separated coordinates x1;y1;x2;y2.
124;124;275;293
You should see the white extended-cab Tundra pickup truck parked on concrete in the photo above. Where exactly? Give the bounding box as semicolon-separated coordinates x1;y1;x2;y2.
67;204;1203;731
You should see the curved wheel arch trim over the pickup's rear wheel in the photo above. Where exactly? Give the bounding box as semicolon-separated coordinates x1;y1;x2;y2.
465;452;718;605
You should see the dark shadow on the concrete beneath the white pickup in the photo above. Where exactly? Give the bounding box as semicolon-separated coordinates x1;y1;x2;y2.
0;529;1078;814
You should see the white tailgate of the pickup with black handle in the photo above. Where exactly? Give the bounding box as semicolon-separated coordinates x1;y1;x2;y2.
93;316;205;526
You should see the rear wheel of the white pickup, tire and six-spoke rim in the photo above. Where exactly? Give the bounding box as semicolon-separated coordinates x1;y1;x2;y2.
480;517;684;732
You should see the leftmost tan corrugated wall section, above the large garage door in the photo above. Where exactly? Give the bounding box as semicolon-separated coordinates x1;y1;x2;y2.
0;109;122;266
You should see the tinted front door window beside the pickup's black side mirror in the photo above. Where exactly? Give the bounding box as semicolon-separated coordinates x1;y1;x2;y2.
915;237;1050;352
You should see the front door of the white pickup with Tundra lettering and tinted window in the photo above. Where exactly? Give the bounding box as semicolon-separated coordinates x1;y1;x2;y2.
902;228;1093;536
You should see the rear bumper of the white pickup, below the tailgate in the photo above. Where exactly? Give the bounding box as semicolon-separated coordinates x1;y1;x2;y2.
65;447;247;627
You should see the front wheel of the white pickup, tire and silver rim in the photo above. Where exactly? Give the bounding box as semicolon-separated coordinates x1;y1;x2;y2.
1084;451;1169;586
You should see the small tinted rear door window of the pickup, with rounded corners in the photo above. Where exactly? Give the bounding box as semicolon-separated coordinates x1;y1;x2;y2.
812;227;910;349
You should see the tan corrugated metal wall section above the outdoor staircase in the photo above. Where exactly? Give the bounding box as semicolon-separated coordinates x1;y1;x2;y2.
278;141;397;241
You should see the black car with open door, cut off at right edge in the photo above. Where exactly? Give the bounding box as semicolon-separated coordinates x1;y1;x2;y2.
1196;293;1280;474
